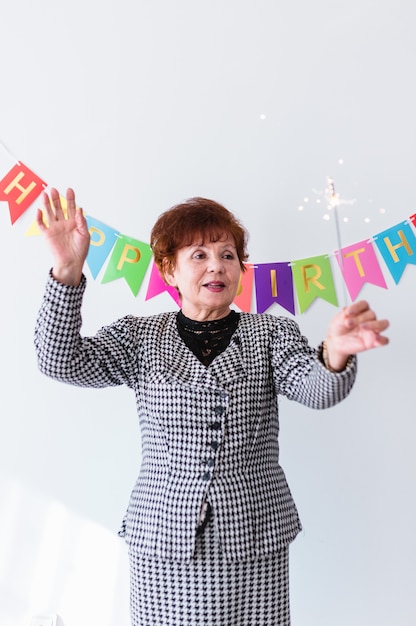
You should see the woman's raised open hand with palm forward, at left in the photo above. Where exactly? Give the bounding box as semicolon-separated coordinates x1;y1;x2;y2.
36;189;90;285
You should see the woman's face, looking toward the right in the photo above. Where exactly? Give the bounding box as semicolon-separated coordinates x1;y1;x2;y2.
166;236;241;321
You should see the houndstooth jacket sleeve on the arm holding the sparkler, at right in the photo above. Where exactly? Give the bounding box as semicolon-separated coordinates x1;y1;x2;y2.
272;318;357;409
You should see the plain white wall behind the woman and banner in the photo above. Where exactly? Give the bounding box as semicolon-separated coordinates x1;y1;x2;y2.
0;0;416;626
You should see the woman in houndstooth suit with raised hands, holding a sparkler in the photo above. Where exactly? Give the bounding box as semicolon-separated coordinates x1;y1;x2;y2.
36;189;388;626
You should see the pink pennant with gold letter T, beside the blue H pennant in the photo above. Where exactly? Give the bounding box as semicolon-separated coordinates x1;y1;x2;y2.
335;241;387;302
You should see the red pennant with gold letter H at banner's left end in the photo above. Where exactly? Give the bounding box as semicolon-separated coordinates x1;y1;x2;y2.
0;162;46;224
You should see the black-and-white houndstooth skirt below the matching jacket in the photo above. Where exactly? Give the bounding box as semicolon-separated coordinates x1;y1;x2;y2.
130;520;290;626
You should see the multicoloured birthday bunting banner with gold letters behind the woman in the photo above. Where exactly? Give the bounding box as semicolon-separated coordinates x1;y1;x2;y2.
0;144;416;315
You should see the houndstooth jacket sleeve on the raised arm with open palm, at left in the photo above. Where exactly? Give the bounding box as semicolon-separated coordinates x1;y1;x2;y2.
35;276;138;387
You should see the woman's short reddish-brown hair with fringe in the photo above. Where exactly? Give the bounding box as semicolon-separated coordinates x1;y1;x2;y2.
150;198;248;276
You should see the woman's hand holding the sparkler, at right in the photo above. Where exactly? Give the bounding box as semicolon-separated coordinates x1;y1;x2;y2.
325;300;389;371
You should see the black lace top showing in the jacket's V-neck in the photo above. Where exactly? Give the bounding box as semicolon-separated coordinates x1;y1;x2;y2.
176;311;240;365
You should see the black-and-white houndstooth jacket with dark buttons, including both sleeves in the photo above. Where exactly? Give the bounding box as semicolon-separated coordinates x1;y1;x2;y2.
35;278;356;560
